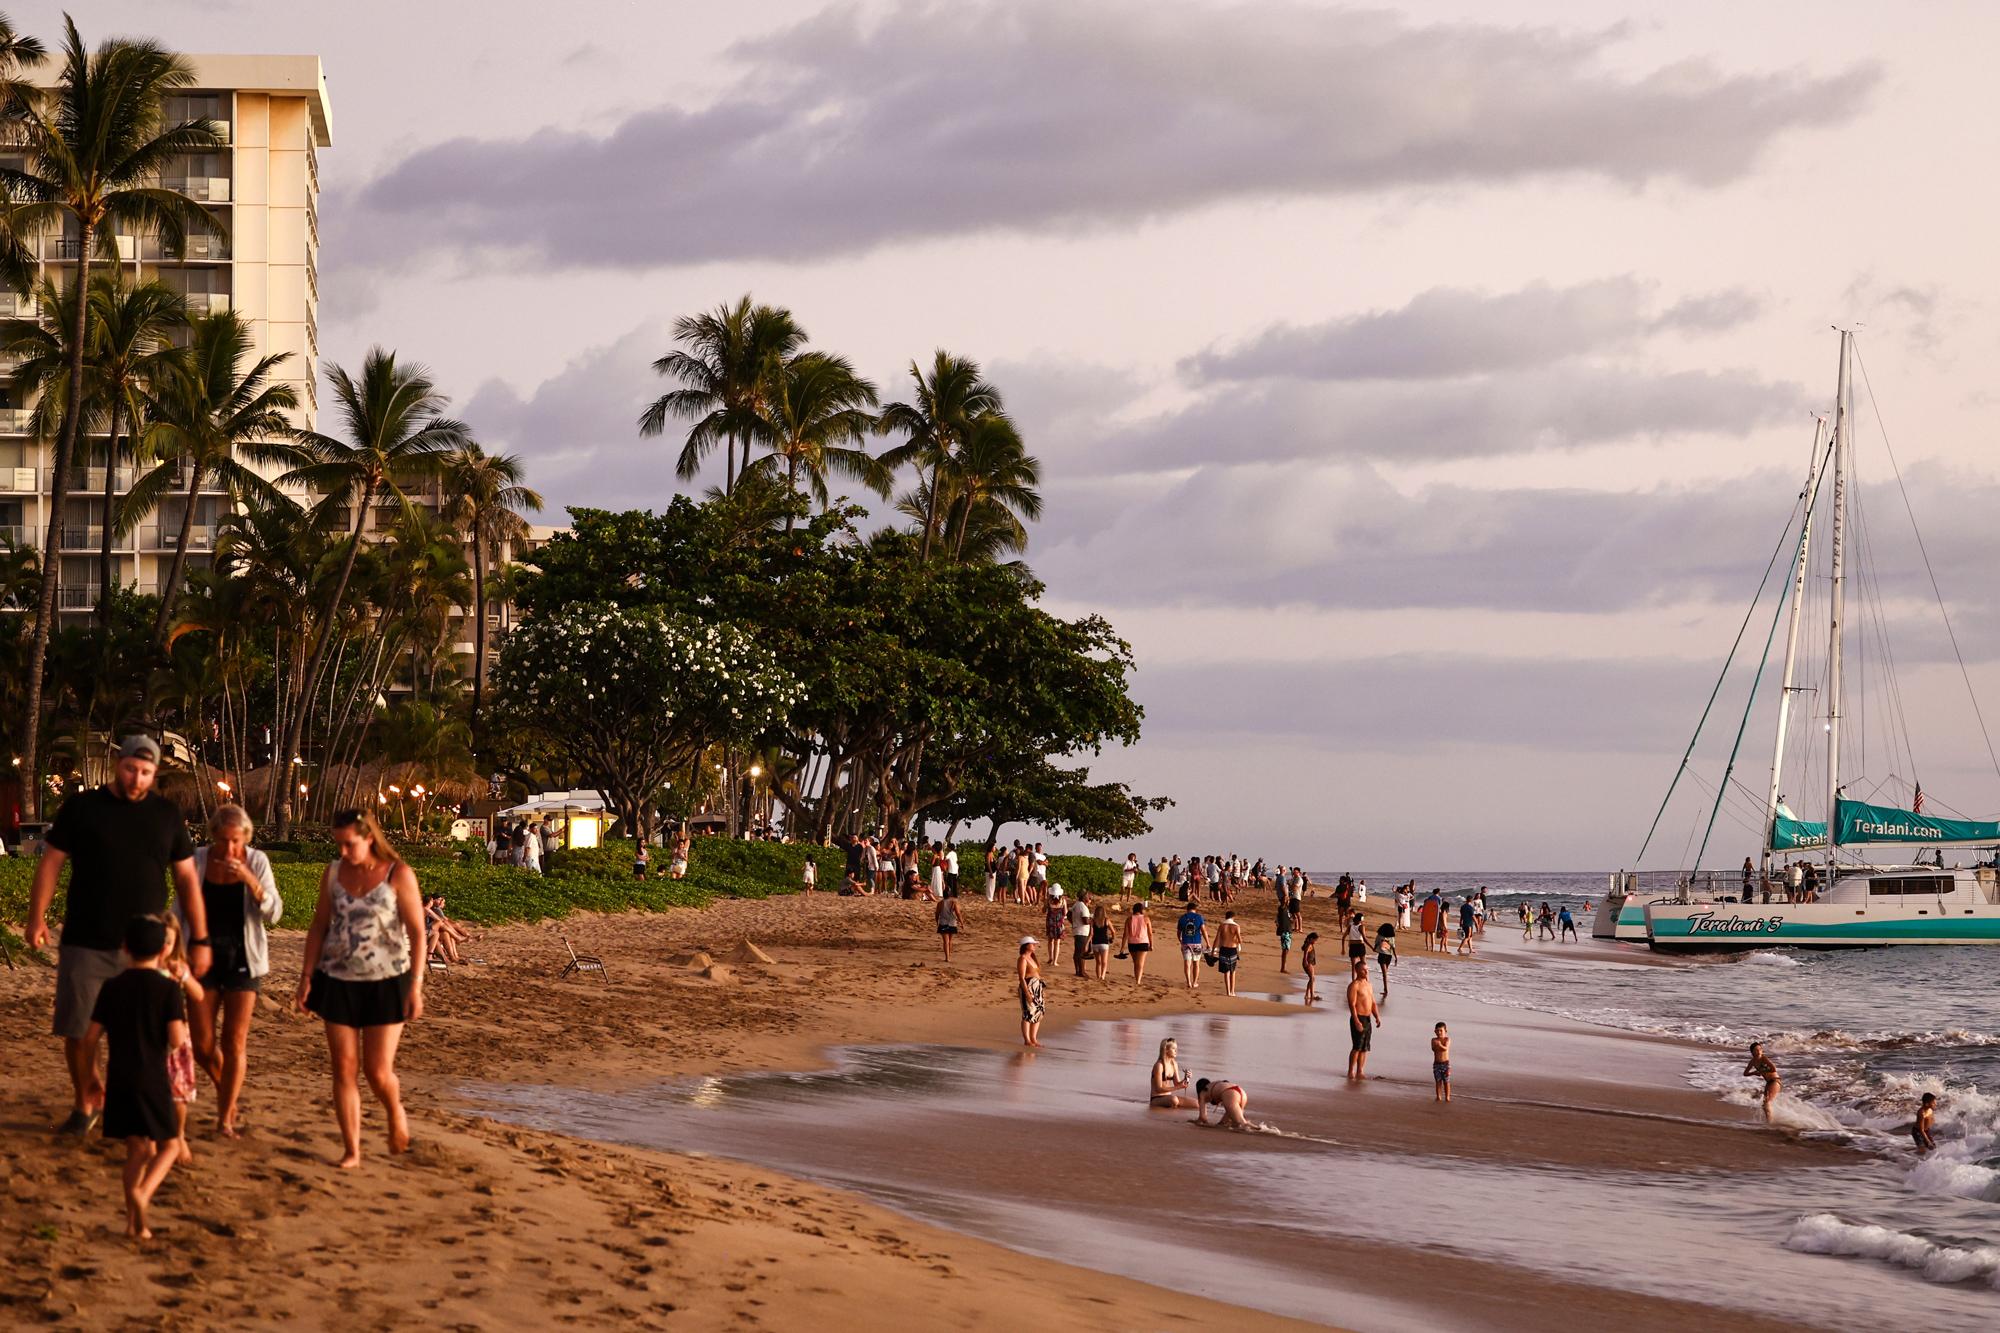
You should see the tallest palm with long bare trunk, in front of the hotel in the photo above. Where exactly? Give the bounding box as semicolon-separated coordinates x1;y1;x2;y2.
0;18;222;817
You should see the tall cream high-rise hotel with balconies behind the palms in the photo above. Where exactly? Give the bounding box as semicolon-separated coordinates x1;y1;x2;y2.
0;56;332;612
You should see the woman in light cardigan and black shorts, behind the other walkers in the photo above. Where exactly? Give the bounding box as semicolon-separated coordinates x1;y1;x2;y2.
174;805;284;1139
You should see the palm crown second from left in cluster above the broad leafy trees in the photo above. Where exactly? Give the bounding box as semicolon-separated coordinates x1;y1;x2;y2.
744;352;888;532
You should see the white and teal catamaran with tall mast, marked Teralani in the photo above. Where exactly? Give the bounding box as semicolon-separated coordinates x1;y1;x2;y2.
1594;332;2000;953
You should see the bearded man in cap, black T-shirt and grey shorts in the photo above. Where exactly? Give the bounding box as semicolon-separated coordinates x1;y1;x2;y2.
26;737;208;1137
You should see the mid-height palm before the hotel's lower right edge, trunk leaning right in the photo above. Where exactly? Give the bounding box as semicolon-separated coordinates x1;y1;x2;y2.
129;310;300;646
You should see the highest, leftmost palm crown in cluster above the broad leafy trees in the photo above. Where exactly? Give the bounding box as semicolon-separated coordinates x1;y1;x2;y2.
638;296;806;494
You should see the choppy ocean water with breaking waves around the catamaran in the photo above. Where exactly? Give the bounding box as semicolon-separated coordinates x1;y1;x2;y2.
1406;881;2000;1321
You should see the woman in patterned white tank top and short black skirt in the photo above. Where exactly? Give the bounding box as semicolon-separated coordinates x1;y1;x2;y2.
296;811;424;1167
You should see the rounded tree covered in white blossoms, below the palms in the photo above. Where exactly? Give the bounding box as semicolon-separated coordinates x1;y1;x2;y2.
494;602;804;837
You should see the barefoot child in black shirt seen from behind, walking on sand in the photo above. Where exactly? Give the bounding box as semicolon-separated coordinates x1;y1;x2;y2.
86;917;190;1241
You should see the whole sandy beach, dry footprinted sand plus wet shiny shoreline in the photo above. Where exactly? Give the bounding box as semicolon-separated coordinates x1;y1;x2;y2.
0;847;1990;1329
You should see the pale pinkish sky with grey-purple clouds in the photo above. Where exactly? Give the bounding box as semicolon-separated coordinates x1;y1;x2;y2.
35;0;2000;869
